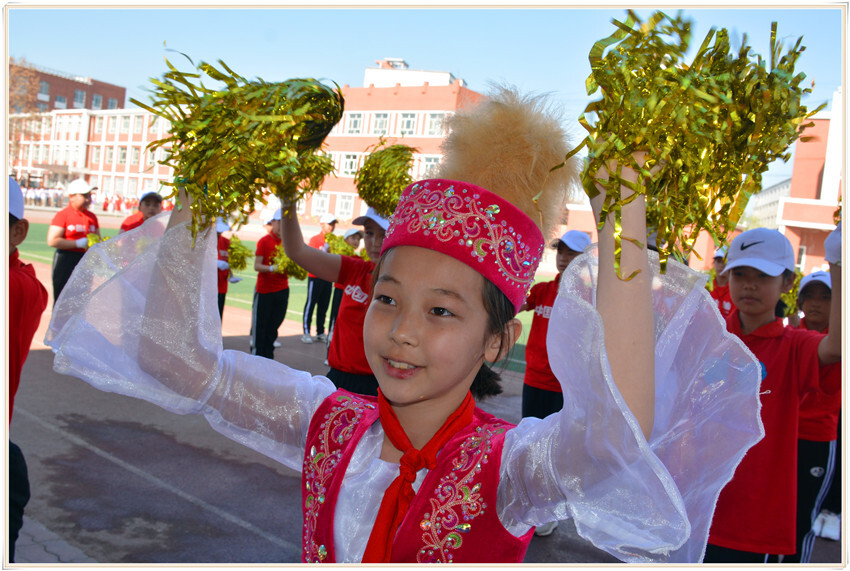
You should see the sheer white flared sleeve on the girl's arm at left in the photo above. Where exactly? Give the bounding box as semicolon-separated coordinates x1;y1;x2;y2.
45;213;335;471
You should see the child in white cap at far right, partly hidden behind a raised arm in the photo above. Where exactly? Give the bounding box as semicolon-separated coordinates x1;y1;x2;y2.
783;271;841;563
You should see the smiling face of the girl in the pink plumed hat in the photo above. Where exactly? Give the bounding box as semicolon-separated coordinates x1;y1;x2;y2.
363;246;501;415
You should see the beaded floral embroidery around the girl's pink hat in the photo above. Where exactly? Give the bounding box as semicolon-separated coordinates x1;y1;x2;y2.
387;180;542;291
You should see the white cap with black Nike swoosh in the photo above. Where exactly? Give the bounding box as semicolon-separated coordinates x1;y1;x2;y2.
723;228;794;276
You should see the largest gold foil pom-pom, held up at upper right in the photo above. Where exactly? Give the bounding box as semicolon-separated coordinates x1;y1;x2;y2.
567;11;825;277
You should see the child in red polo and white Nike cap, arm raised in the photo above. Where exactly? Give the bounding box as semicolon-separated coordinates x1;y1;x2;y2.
704;224;841;563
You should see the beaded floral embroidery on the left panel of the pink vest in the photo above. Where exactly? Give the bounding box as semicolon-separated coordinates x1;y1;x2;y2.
303;395;375;563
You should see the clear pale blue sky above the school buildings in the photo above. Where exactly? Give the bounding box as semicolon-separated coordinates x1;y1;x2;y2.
7;3;846;185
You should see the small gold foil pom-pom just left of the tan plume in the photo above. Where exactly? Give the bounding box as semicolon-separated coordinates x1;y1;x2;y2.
354;138;418;218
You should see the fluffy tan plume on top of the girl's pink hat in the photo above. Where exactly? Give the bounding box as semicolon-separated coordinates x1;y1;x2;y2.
437;86;580;239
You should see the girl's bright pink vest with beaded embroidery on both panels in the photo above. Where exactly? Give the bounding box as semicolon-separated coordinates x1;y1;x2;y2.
301;390;533;563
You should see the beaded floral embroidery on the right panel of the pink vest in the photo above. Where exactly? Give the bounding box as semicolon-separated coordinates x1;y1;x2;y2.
416;425;505;563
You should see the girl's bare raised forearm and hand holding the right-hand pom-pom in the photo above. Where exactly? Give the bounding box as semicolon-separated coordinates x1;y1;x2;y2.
592;154;655;438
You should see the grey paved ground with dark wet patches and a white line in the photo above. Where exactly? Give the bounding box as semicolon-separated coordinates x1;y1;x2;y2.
4;207;846;566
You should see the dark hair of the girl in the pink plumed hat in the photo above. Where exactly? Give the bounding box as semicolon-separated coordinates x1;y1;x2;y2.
371;252;516;400
